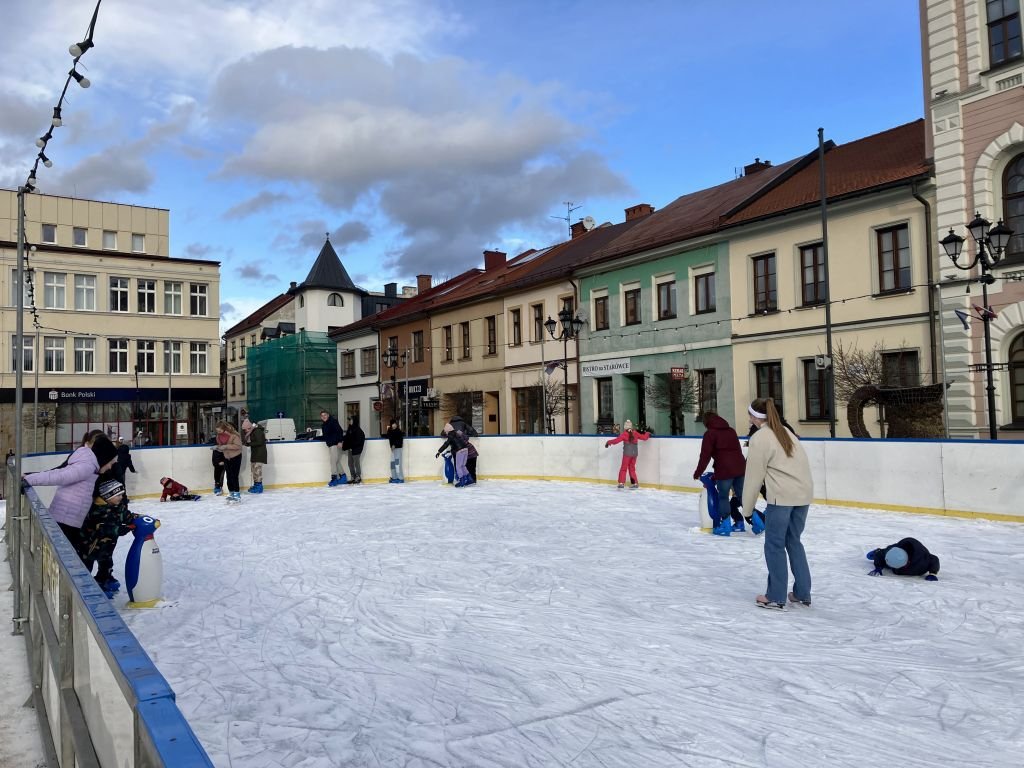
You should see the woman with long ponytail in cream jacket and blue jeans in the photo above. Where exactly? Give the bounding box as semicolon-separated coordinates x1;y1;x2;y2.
743;397;814;610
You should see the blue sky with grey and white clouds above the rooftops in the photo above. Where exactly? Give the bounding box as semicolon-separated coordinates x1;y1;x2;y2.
0;0;924;325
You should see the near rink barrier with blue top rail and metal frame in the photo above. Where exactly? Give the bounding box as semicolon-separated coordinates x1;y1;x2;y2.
4;462;213;768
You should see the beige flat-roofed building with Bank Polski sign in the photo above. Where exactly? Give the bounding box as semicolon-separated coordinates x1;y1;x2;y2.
0;189;220;452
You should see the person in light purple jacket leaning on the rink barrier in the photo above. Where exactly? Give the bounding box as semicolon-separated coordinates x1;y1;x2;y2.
25;434;118;556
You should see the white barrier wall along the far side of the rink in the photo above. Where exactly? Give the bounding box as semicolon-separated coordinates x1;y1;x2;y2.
24;435;1024;521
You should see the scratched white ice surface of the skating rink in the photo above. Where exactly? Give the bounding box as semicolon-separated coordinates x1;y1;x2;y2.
116;476;1024;768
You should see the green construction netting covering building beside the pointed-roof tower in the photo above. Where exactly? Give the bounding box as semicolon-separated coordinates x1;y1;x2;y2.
246;331;338;432
